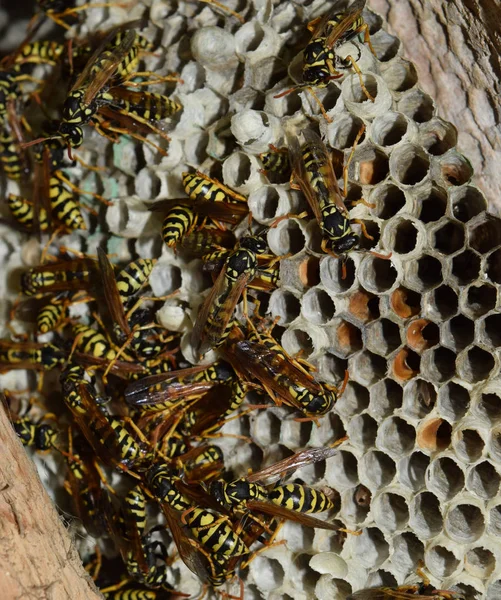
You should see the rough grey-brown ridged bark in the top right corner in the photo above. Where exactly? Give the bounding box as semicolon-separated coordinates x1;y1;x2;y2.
368;0;501;213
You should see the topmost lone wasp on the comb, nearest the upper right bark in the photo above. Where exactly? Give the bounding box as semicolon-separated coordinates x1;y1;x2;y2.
275;0;375;122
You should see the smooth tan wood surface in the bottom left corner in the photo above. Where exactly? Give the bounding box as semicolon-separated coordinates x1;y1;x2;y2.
0;406;102;600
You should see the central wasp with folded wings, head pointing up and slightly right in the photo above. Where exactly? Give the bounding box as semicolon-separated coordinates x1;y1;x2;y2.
191;236;266;357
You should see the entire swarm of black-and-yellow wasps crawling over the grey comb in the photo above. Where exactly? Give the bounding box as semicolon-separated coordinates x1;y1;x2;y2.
0;0;457;600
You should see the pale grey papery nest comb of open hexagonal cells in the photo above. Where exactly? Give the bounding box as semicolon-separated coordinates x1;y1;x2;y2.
0;0;501;600
